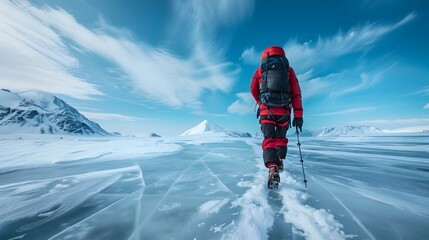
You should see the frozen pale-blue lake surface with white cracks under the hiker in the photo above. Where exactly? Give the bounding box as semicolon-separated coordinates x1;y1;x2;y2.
0;136;429;240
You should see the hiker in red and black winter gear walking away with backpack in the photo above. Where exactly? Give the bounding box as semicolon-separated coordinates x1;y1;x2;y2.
250;46;303;188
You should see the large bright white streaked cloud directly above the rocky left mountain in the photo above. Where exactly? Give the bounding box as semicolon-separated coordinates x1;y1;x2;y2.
0;1;102;99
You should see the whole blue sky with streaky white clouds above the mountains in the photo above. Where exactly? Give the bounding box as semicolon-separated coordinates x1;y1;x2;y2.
0;0;429;136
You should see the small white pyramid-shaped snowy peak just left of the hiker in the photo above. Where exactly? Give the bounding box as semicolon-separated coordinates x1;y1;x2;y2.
180;120;252;137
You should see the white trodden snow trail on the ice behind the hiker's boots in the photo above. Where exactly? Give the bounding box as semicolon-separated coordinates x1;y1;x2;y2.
231;140;346;240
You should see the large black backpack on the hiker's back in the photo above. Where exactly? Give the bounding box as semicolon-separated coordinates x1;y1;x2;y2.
259;56;291;107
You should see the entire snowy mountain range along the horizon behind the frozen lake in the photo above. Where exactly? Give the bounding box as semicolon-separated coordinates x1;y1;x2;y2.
0;89;429;137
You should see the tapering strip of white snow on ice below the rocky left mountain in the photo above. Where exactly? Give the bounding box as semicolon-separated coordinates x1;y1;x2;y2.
0;135;181;173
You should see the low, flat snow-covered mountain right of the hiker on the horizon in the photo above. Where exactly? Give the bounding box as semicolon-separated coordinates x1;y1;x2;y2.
319;125;384;136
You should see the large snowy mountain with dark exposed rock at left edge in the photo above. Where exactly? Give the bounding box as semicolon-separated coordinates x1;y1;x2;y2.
0;89;110;135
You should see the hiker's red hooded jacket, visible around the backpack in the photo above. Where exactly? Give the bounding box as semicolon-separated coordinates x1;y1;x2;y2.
250;46;303;117
